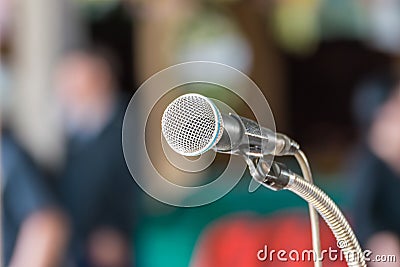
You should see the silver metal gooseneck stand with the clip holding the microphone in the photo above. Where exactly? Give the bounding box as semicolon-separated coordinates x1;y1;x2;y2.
246;157;367;267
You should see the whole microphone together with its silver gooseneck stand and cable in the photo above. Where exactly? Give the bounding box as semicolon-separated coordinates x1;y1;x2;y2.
161;94;367;267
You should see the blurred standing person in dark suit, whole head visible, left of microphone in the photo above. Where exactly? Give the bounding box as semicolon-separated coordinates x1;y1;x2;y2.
54;49;137;267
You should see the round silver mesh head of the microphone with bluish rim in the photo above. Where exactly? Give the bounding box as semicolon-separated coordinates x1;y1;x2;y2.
161;94;223;156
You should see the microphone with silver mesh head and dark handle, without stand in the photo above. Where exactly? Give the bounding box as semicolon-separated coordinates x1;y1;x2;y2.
161;93;299;157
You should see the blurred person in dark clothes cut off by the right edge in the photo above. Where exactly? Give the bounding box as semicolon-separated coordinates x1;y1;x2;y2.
354;84;400;266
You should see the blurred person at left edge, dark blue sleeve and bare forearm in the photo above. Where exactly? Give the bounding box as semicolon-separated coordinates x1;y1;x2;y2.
1;128;68;267
